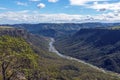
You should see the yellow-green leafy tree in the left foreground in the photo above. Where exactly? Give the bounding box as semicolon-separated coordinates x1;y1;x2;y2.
0;36;38;80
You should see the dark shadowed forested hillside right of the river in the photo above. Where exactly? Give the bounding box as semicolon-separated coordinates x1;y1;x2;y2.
55;29;120;73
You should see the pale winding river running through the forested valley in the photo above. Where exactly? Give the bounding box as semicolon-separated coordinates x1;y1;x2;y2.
49;38;107;73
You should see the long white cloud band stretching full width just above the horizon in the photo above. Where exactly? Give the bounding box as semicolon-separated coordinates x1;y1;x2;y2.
0;10;120;24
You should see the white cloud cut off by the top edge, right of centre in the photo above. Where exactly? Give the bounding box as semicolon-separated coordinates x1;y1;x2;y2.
69;0;109;6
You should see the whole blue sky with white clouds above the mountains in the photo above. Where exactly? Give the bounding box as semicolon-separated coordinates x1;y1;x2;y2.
0;0;120;24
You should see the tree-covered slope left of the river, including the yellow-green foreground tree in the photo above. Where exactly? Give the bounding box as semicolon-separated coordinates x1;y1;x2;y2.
0;28;120;80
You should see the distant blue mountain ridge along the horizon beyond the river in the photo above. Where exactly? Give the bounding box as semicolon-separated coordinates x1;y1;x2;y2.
1;23;120;37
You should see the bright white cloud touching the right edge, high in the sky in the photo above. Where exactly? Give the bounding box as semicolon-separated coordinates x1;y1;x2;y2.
88;2;120;11
